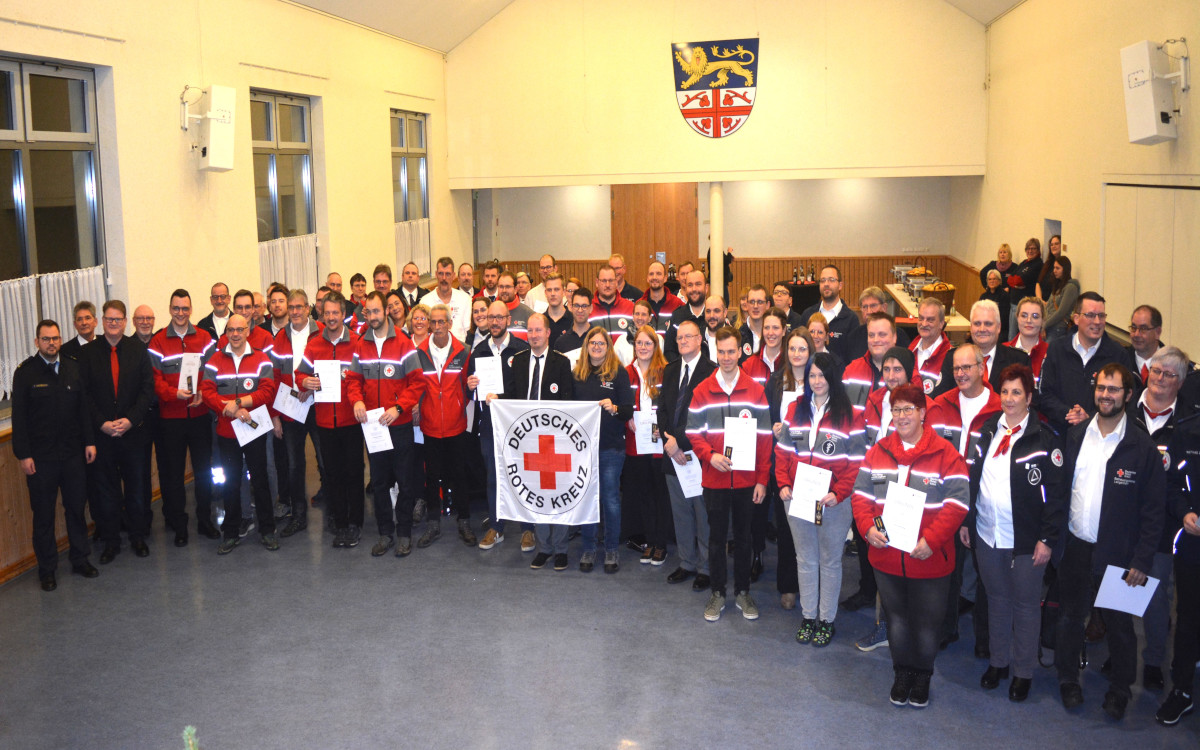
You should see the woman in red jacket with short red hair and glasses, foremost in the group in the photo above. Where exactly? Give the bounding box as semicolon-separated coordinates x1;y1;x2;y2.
852;384;970;708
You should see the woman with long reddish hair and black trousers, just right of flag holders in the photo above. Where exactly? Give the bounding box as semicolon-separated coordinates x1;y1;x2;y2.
622;325;671;565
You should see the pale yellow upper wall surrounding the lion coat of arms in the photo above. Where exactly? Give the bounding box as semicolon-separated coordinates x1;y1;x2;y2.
446;0;986;188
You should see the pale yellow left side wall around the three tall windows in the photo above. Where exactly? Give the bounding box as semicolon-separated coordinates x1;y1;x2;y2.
0;0;472;309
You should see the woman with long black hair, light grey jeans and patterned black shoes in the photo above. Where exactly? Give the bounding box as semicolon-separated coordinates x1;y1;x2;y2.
775;350;863;647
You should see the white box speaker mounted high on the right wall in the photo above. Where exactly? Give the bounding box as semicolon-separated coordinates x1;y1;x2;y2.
1121;42;1178;145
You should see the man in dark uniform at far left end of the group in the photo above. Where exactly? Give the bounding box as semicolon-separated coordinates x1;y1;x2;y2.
12;320;100;592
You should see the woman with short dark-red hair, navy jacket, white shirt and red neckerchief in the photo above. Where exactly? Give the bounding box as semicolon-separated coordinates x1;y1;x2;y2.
959;365;1070;702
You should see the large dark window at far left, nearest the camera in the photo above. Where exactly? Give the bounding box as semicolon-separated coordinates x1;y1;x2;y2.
0;59;103;280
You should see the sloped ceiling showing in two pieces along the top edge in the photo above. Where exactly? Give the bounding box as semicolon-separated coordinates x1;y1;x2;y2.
289;0;1024;52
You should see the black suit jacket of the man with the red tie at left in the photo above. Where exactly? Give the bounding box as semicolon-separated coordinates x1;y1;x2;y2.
79;336;154;439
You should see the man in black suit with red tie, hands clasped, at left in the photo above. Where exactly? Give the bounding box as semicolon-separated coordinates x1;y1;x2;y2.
79;300;154;565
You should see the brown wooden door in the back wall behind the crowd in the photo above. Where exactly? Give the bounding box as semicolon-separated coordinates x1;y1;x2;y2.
612;182;698;289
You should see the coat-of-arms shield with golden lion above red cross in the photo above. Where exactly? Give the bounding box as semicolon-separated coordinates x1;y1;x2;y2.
671;38;758;138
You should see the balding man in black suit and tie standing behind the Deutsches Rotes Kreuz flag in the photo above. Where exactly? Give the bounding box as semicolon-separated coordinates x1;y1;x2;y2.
504;312;575;570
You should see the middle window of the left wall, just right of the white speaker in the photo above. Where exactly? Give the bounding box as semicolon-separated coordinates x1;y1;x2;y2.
250;91;314;242
